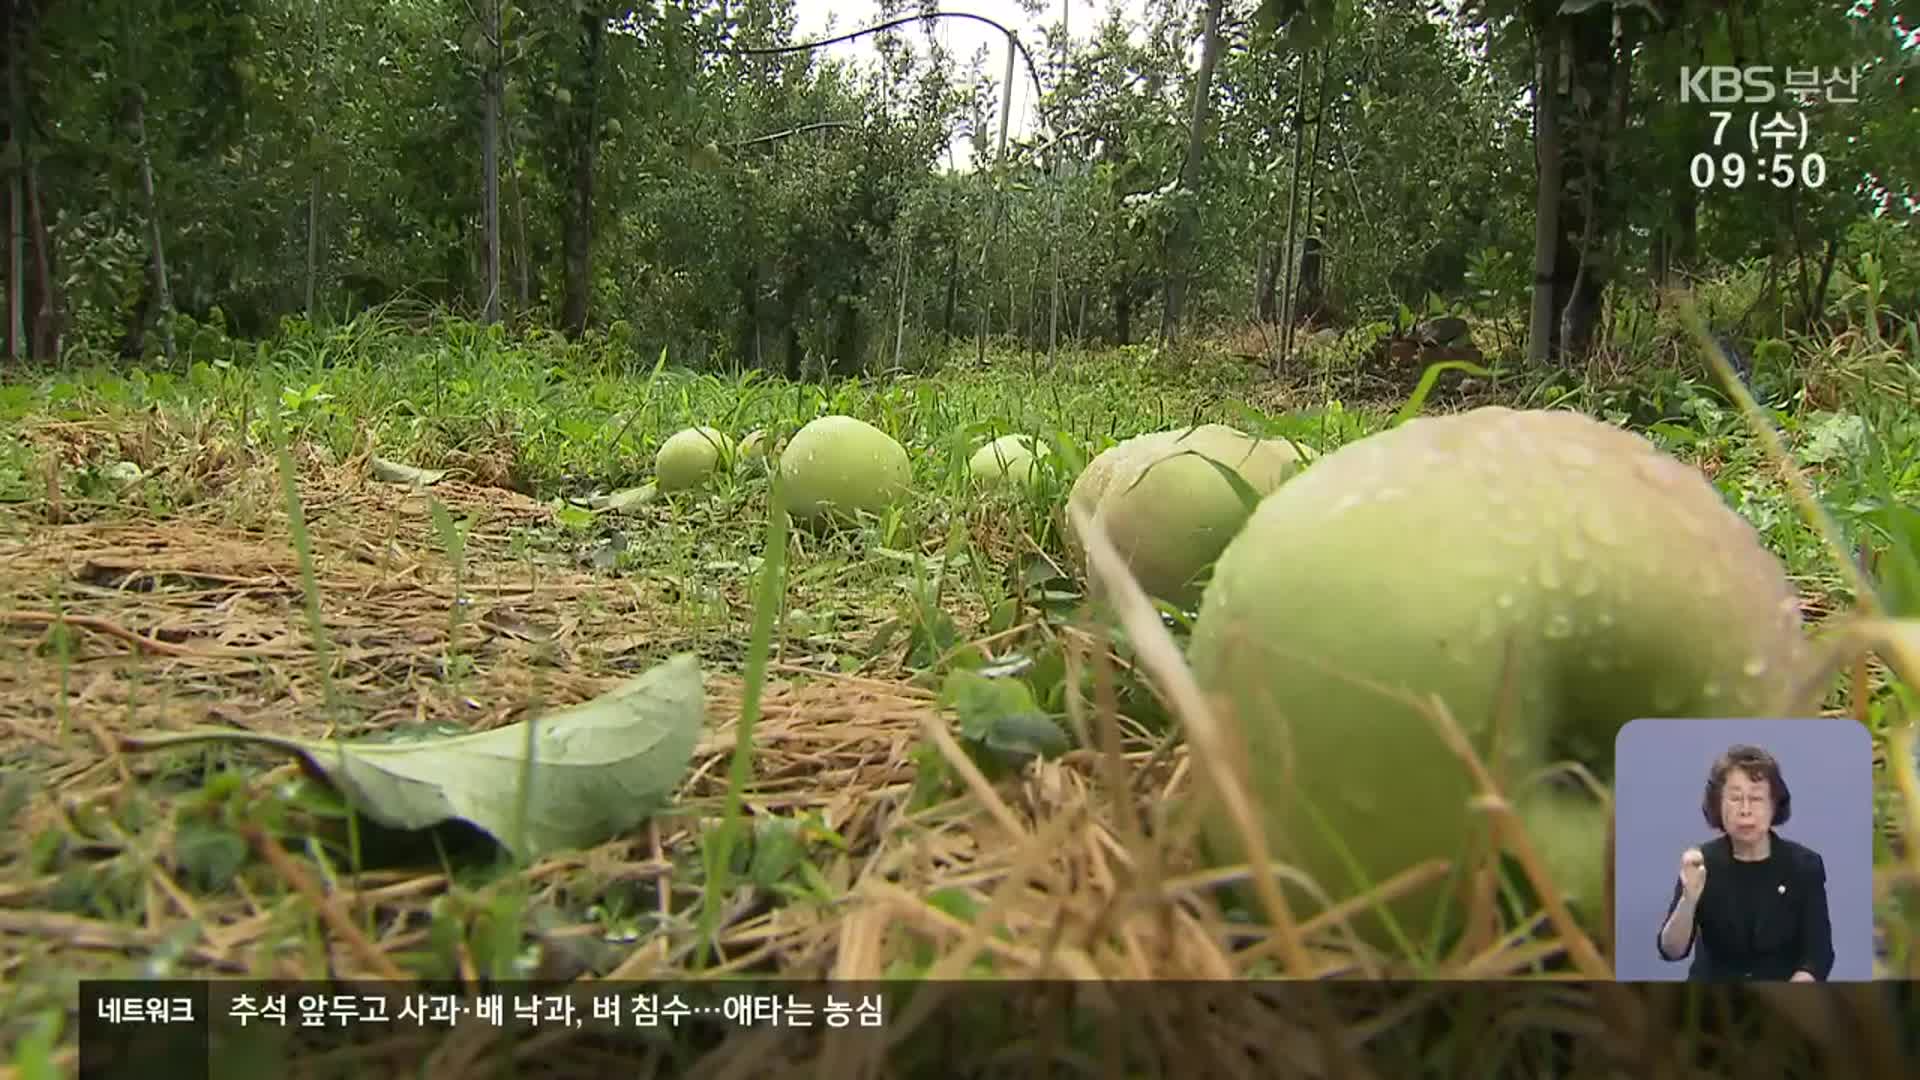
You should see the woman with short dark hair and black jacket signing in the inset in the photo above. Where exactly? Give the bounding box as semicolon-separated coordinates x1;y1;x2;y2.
1657;746;1834;982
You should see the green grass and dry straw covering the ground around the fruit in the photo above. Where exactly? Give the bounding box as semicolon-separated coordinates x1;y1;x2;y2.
0;295;1920;1076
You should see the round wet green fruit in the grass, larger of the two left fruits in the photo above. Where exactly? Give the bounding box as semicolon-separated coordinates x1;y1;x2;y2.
780;417;914;523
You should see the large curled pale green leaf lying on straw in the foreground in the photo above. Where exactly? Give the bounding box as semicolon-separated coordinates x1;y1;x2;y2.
119;653;707;859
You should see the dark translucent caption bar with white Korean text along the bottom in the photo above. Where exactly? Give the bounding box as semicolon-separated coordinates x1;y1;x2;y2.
79;980;1920;1080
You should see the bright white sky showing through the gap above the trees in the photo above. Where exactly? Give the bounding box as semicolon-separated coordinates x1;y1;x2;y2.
793;0;1146;161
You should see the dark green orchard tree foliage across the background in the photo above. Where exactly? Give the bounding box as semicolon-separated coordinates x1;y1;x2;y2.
11;0;1920;363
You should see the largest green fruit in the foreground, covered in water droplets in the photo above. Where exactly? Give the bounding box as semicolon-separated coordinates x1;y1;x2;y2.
1188;407;1807;945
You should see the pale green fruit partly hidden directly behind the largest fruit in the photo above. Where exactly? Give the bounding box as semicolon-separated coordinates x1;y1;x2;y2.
1066;425;1302;607
